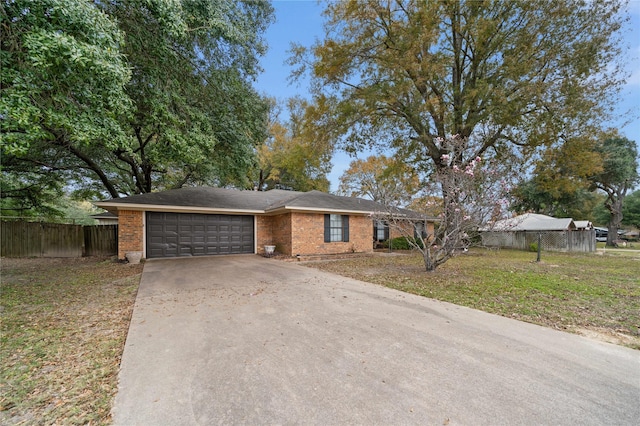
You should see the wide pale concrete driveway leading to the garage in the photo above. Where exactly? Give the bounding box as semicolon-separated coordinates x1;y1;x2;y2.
113;255;640;425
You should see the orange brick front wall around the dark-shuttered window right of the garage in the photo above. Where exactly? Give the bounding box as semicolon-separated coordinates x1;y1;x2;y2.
290;213;373;256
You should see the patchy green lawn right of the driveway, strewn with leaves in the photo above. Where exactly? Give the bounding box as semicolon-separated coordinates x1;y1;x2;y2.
308;250;640;349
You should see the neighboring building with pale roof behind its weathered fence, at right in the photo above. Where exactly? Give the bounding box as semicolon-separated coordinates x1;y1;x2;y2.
481;213;596;252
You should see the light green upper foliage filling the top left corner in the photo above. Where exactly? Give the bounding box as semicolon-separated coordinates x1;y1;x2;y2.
0;0;129;155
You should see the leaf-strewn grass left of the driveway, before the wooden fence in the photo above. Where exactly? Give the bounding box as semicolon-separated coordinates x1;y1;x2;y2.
0;258;142;424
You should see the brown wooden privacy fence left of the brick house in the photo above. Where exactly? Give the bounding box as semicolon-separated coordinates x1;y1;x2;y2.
0;221;118;257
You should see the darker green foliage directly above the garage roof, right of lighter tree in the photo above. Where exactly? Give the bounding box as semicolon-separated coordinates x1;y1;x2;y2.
104;0;272;195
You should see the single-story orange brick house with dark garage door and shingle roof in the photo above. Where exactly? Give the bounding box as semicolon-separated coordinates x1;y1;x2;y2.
95;187;436;259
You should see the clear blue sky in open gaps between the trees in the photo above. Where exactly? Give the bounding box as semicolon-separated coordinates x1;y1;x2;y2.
256;0;640;191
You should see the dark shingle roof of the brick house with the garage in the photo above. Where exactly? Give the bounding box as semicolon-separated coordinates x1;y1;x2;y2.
95;187;430;217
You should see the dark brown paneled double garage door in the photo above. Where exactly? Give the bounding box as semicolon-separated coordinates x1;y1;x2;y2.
146;212;254;258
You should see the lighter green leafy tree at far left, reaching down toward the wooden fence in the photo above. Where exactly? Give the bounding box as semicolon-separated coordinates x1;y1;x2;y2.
0;0;130;215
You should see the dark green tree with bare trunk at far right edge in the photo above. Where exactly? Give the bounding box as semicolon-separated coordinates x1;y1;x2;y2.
590;137;640;246
